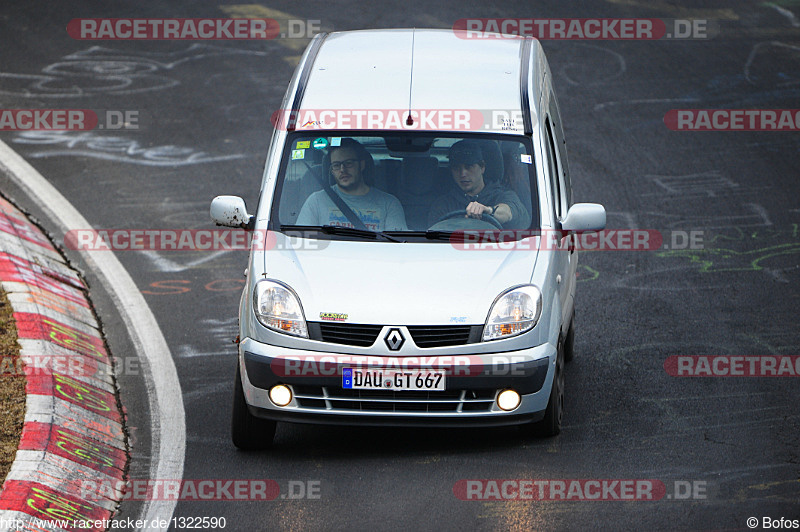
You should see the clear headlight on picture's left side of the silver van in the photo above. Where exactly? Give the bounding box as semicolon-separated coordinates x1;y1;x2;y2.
253;280;308;338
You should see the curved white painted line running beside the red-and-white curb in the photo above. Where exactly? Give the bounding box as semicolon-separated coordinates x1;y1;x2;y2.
0;141;186;530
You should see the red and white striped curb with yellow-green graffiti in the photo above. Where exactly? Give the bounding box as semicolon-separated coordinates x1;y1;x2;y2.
0;198;128;531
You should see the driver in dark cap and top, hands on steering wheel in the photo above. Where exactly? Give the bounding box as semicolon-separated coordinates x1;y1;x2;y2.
428;140;530;229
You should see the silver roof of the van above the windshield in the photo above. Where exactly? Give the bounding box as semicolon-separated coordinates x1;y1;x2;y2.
290;29;540;134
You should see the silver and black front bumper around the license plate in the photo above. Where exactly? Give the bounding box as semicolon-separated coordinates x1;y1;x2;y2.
239;339;556;427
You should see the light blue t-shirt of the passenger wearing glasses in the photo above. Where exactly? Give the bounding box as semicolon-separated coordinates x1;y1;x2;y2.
295;185;408;231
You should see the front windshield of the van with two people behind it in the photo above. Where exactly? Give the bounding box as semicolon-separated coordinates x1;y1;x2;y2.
271;131;539;238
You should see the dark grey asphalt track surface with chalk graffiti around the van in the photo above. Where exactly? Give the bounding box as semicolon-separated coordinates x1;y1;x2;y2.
0;0;800;530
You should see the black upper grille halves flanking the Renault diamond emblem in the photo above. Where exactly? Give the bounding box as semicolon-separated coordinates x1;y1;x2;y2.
308;321;483;348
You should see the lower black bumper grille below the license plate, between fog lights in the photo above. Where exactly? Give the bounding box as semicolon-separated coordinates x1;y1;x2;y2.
292;385;497;414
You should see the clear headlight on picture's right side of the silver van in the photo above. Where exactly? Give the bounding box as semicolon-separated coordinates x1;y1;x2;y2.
483;285;542;342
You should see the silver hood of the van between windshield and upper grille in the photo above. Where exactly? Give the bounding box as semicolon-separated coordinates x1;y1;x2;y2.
264;233;537;325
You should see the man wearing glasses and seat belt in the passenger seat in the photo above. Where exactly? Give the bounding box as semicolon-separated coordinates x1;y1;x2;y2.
296;138;408;231
